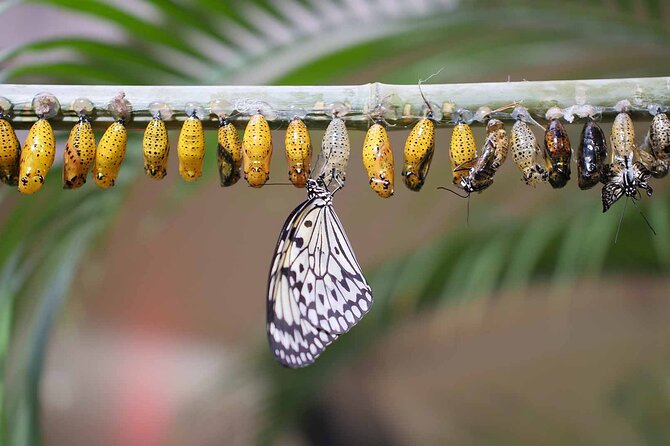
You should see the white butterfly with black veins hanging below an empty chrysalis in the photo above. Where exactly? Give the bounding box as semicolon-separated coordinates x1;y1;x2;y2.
267;176;372;368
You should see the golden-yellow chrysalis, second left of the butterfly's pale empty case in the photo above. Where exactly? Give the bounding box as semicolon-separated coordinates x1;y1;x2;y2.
242;113;272;187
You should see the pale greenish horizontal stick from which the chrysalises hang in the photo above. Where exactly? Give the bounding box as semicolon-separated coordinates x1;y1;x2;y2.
0;77;670;129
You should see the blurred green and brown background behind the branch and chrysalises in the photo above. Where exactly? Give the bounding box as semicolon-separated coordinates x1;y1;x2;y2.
0;0;670;446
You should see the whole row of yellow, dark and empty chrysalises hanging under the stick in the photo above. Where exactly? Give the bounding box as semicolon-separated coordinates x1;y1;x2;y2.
0;94;670;211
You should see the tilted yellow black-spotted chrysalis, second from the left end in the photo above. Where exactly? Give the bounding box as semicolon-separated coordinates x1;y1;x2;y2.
19;118;56;194
